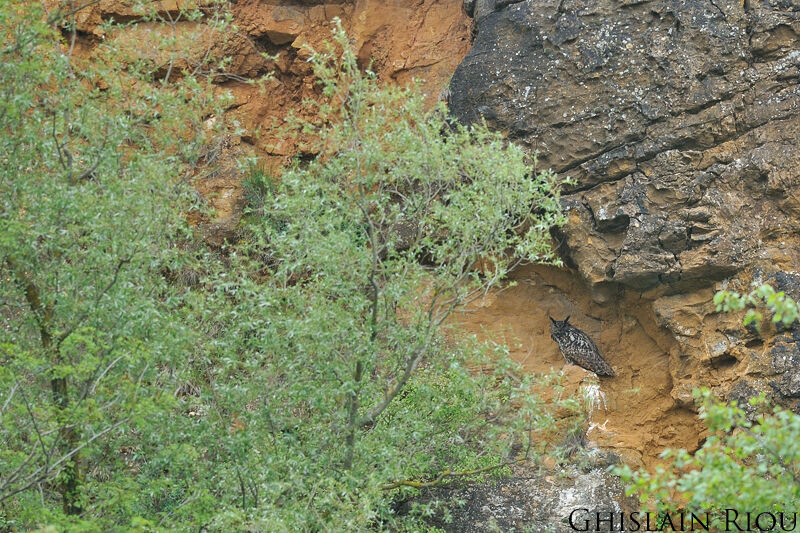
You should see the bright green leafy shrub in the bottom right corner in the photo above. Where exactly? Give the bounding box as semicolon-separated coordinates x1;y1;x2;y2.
617;390;800;530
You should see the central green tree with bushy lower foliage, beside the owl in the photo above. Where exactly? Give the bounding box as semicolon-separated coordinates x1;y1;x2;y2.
186;20;564;530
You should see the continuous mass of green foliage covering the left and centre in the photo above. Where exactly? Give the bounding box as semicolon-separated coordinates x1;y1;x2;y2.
0;6;563;531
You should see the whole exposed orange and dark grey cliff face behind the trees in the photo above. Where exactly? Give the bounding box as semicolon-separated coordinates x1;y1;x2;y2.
64;0;800;465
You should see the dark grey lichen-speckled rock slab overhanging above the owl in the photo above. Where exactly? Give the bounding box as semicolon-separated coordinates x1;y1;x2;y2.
450;0;800;290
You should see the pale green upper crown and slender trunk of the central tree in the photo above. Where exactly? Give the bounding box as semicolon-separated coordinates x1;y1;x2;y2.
272;20;564;469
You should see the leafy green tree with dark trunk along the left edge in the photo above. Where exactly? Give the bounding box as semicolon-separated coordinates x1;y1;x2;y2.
0;2;234;529
